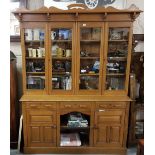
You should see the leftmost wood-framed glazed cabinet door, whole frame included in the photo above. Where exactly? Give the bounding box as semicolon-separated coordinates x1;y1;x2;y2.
21;22;48;94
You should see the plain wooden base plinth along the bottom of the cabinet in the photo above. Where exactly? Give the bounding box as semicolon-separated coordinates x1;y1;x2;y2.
24;147;127;155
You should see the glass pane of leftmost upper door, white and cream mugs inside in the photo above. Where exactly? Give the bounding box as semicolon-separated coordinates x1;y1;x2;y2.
24;28;45;89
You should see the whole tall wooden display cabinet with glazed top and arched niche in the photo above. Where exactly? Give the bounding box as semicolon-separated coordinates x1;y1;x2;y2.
14;5;141;154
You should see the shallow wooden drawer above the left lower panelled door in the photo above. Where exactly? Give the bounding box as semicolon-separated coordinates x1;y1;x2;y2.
26;102;56;110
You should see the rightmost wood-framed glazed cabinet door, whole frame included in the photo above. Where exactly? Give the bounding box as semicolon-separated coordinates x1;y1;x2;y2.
103;22;132;95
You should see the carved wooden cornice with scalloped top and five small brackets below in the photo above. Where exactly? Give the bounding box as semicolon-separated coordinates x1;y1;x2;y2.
13;4;142;22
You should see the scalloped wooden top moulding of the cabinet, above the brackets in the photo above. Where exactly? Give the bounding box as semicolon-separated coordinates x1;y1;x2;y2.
13;4;143;14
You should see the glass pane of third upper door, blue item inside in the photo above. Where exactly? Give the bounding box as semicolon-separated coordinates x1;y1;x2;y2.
79;28;101;90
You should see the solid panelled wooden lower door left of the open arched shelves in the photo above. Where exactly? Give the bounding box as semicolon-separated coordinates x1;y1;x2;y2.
26;105;56;147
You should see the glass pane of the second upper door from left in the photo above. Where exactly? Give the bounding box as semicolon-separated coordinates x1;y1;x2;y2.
51;28;72;90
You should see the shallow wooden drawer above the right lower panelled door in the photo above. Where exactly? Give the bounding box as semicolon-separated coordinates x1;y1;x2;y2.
96;102;126;109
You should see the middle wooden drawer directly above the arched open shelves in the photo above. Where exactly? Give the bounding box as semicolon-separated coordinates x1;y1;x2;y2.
60;102;91;110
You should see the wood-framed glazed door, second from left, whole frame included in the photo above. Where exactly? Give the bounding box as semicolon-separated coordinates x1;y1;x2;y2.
49;22;76;94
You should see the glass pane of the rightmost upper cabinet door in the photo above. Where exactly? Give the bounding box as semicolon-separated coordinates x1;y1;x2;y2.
105;28;129;90
